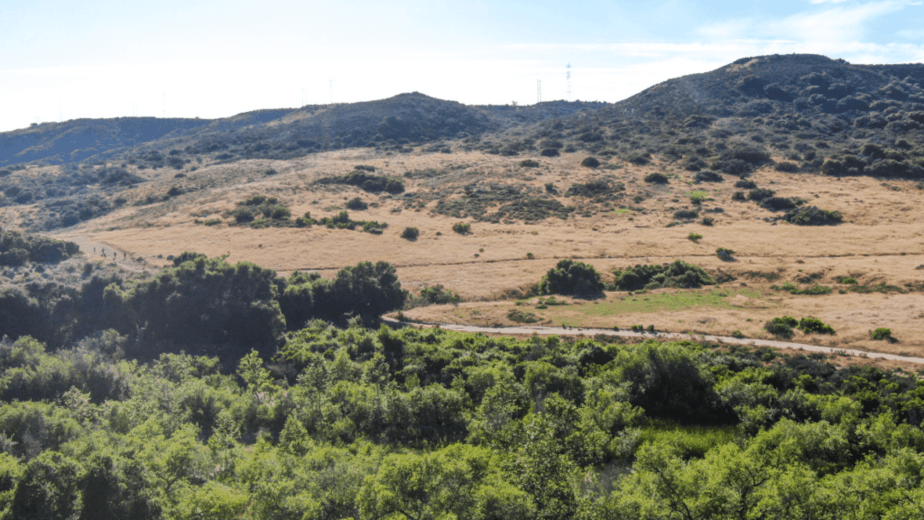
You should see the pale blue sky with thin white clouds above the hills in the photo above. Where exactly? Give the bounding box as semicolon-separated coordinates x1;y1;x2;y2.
0;0;924;132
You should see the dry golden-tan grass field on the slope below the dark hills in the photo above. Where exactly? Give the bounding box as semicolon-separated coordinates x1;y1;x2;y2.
2;144;924;355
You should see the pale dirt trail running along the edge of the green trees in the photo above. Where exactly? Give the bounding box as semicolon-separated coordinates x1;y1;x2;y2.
382;316;924;365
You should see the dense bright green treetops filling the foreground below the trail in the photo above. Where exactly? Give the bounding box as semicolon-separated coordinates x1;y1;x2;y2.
0;320;924;520
